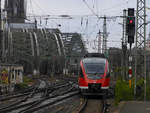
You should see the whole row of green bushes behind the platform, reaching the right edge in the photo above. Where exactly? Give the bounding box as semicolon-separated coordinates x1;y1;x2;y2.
115;78;150;104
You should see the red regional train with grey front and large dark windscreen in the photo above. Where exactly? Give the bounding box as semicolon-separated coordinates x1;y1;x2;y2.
78;53;110;95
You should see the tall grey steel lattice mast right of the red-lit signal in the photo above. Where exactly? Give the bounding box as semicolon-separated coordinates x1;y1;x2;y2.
134;0;146;100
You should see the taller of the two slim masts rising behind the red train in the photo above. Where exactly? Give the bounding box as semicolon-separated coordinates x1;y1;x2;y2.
102;16;107;53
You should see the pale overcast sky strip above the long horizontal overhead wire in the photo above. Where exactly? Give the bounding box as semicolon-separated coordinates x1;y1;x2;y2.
27;0;137;15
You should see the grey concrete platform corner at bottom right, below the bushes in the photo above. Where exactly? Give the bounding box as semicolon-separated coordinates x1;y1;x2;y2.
114;101;150;113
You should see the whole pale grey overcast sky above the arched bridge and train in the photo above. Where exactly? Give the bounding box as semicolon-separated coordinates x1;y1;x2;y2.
3;0;150;51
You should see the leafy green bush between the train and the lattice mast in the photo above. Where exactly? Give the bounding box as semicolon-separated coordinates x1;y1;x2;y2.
115;80;134;104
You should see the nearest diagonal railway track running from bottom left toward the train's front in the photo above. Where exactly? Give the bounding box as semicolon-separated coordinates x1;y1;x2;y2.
0;87;79;113
